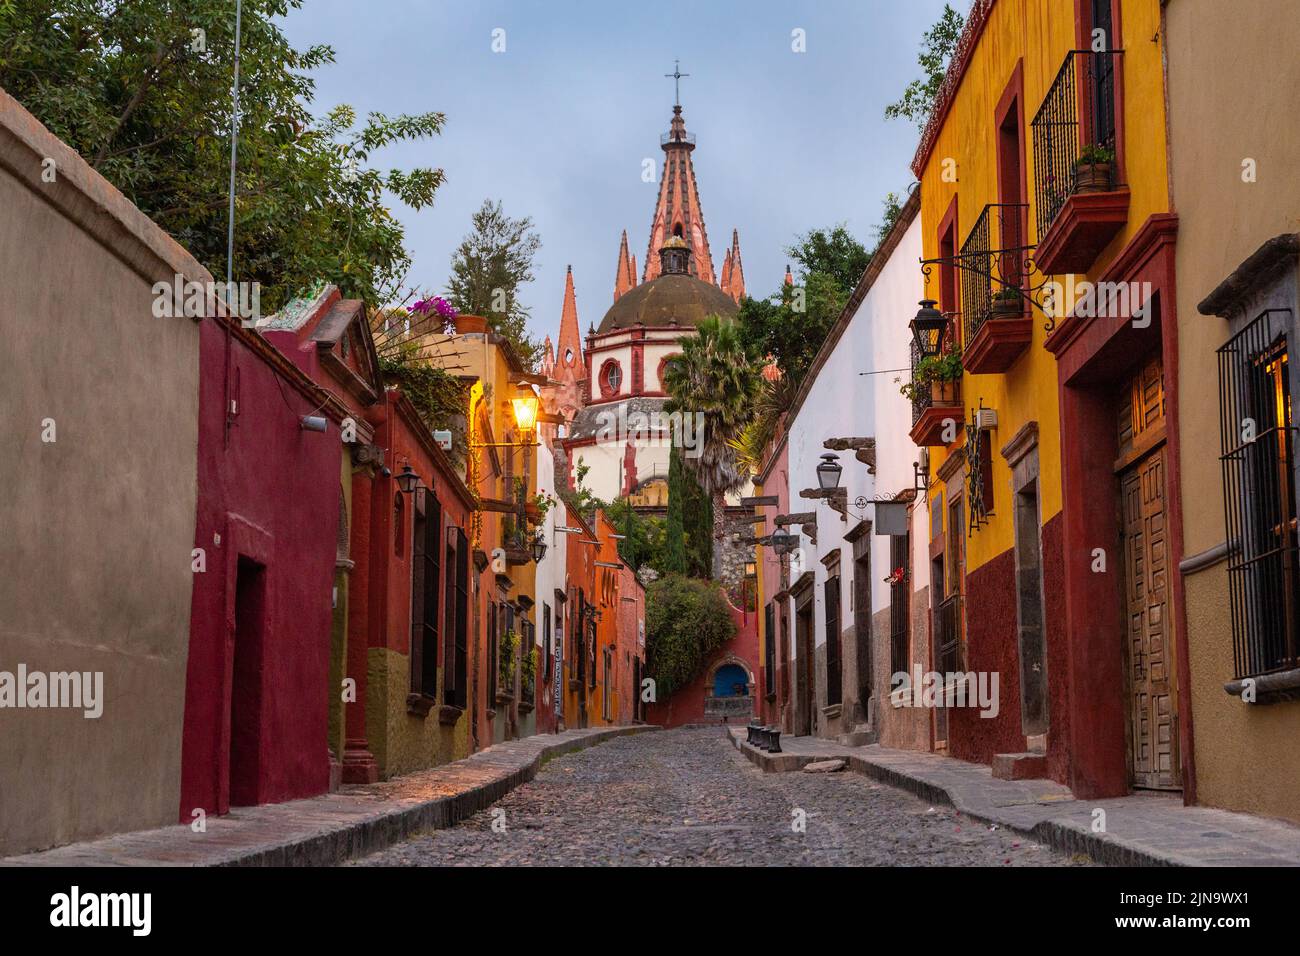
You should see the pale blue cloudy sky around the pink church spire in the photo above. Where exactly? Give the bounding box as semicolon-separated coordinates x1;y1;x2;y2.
282;0;944;351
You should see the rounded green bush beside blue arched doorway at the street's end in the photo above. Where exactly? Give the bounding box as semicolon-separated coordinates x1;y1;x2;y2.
646;575;736;700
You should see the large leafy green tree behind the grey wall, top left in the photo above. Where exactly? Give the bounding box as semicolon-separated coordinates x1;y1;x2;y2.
0;0;445;312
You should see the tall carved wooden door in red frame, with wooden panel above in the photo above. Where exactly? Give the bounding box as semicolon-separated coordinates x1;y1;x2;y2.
1119;363;1182;790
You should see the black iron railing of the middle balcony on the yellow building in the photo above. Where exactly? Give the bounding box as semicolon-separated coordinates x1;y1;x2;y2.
958;203;1028;345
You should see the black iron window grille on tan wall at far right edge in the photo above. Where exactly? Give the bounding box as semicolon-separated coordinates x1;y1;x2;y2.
1218;310;1300;678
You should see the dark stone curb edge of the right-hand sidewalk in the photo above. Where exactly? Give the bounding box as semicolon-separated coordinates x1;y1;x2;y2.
727;731;1190;866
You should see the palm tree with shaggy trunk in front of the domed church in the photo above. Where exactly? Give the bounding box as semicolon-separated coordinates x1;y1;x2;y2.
664;315;763;578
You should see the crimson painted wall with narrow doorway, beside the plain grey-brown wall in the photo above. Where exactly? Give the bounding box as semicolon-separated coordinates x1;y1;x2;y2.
179;319;342;822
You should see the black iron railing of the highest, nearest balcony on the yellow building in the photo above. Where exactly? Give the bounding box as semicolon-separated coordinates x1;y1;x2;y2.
1032;49;1123;239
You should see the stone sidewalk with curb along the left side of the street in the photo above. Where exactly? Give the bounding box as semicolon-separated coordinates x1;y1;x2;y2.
0;726;658;866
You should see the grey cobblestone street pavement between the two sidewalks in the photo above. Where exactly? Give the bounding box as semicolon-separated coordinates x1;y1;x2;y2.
351;728;1091;866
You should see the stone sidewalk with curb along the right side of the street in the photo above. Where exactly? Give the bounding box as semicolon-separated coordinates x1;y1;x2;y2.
728;727;1300;866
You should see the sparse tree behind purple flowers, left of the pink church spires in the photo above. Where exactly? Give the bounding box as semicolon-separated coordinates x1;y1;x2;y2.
447;199;542;368
